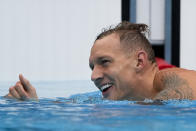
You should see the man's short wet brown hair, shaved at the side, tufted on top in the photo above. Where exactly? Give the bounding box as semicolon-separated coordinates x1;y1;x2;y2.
95;21;155;63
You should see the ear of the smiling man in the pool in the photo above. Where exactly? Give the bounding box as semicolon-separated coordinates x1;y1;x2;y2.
136;50;147;72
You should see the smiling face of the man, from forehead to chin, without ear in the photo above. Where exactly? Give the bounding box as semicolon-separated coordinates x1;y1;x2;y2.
89;34;140;100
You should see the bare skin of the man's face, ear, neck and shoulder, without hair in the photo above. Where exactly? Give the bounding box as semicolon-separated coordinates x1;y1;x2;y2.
89;34;196;100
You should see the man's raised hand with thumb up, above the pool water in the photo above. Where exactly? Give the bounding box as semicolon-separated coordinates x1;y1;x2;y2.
5;74;38;100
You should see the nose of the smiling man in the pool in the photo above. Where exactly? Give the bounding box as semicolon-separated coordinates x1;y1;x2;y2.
91;66;103;82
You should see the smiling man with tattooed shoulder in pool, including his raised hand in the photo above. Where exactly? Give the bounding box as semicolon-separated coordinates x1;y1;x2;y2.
4;22;196;101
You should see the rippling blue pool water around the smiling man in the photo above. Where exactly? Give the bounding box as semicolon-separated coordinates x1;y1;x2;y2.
0;81;196;131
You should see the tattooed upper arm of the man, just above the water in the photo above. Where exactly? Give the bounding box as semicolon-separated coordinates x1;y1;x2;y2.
154;72;193;100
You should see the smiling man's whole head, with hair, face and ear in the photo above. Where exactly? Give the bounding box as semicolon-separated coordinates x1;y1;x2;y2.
89;22;155;100
